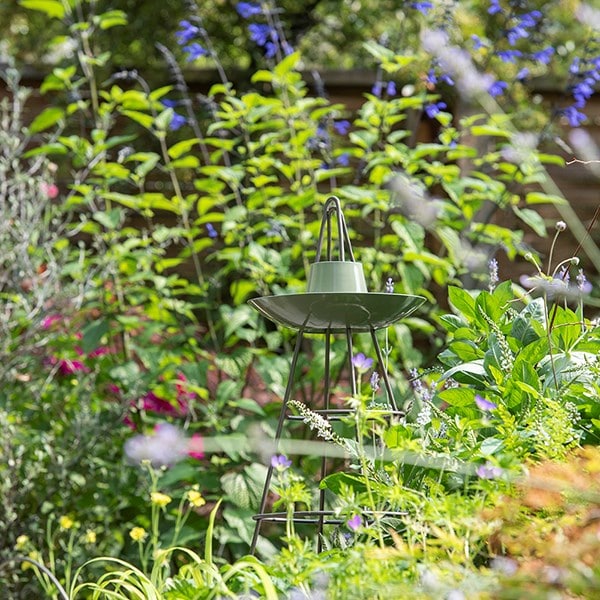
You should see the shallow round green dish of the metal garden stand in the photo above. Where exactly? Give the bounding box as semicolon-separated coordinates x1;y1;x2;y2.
249;292;425;333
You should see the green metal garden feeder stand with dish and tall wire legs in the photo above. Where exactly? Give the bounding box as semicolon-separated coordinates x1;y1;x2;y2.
250;196;425;553
